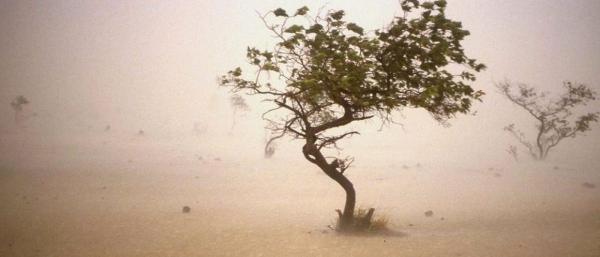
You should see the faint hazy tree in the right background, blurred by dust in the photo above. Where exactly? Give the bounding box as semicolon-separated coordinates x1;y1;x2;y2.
496;81;599;160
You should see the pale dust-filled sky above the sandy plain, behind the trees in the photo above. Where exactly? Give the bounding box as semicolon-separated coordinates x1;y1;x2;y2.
0;0;600;164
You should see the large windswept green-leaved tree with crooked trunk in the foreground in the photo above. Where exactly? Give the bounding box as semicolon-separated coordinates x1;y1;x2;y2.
220;0;485;230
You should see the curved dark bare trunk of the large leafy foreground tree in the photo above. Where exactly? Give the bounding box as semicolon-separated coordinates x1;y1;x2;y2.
302;140;356;230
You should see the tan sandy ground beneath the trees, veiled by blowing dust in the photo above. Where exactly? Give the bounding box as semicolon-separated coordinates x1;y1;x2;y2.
0;133;600;257
